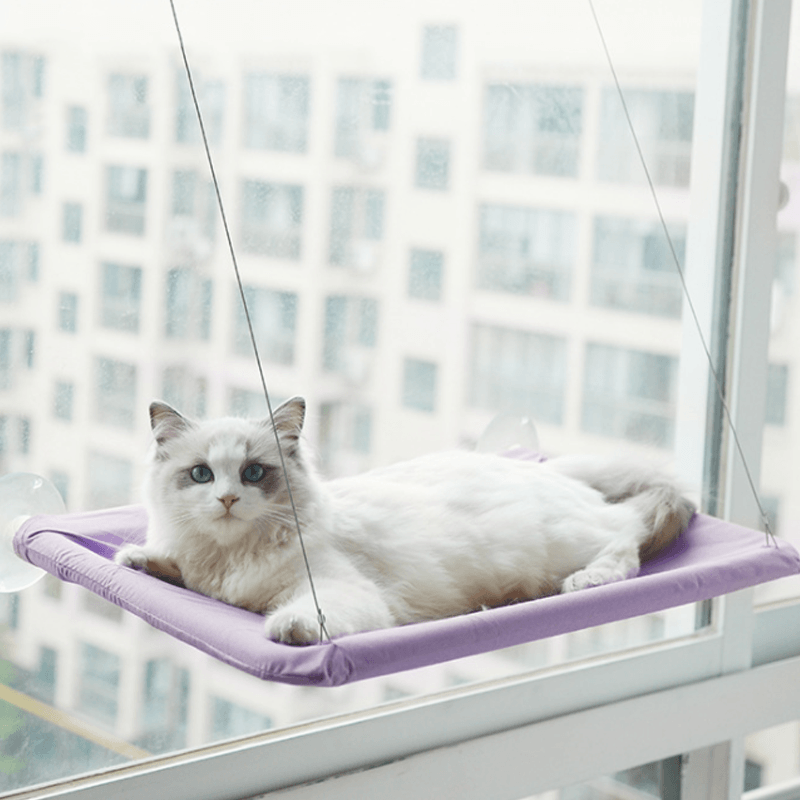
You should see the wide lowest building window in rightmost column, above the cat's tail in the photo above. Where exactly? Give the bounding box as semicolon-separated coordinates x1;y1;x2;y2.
581;343;678;447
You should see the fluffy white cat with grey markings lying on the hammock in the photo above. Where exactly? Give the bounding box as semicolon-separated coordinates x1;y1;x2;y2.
116;398;694;644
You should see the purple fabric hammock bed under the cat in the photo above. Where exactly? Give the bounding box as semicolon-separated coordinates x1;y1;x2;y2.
14;506;800;686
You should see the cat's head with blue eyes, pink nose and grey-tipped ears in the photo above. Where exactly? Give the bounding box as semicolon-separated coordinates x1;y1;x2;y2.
146;398;305;544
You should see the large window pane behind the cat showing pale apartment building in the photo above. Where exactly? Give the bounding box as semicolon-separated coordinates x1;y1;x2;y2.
0;0;712;789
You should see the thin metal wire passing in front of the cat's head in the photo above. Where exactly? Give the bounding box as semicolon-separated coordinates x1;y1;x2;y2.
169;0;331;641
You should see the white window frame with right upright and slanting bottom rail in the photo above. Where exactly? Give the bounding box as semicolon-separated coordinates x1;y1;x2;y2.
12;0;800;800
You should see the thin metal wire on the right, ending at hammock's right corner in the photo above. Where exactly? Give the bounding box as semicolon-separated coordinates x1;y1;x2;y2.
587;0;775;545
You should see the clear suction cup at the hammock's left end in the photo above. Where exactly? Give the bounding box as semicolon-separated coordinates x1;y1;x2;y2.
0;472;65;592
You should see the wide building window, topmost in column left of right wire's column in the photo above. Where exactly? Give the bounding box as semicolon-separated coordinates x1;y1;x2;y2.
483;83;583;177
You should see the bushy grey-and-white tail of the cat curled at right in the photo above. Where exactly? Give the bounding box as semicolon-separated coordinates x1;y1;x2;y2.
549;456;696;561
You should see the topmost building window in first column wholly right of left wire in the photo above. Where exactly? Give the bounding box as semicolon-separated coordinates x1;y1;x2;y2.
244;73;309;153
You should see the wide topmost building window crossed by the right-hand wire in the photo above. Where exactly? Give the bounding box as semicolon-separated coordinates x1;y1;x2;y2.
597;88;694;186
